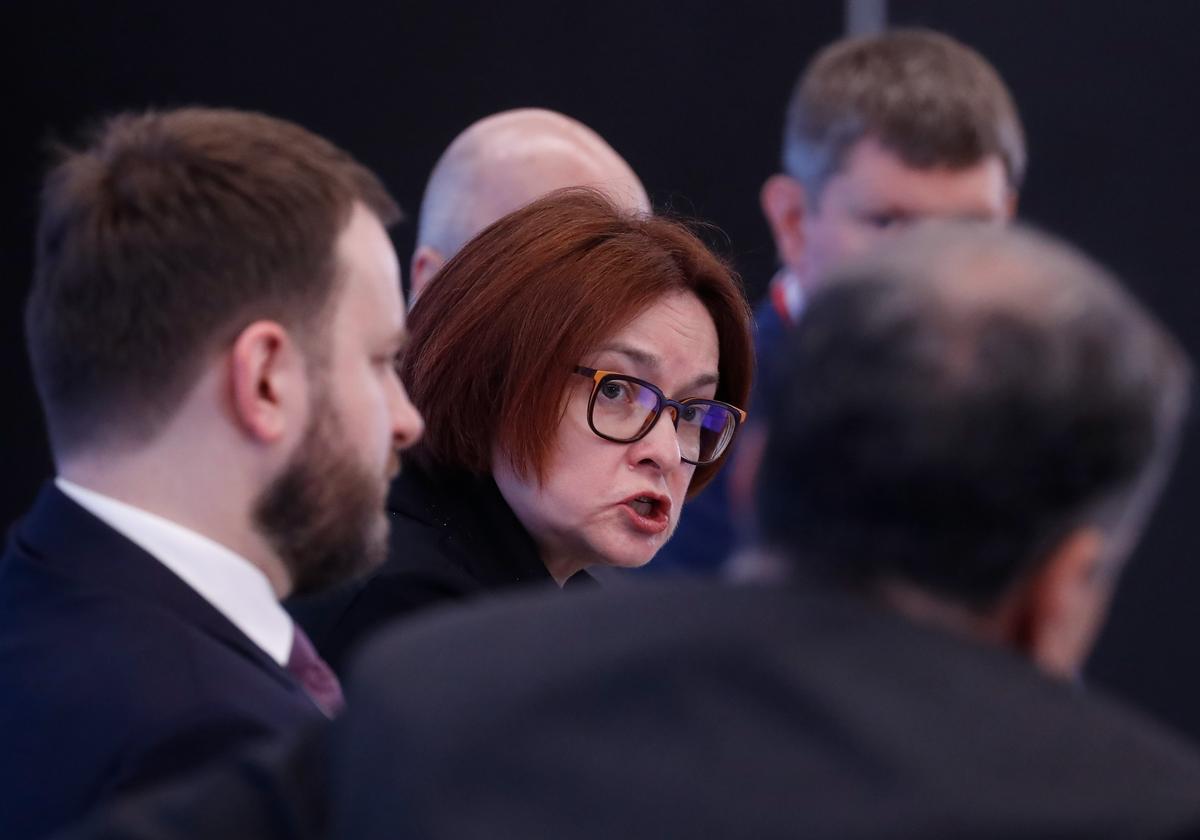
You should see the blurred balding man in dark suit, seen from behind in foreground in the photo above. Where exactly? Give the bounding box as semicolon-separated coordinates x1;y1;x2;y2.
334;223;1200;840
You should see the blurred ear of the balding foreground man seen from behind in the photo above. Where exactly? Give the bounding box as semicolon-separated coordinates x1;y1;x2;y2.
1013;527;1114;678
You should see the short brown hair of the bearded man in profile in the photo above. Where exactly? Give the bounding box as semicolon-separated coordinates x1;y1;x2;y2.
25;108;400;456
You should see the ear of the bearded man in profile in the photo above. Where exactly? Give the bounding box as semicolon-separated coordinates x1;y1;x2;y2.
228;320;308;443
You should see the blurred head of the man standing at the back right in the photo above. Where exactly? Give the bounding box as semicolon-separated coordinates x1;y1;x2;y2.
762;30;1025;295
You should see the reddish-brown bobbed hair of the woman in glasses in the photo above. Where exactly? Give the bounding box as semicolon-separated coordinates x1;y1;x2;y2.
401;188;754;494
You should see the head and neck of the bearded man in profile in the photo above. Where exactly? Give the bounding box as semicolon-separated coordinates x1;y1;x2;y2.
25;108;421;594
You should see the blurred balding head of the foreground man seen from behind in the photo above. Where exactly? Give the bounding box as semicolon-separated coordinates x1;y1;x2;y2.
757;223;1188;673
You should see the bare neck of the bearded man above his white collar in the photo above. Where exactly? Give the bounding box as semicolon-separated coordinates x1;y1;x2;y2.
58;448;292;600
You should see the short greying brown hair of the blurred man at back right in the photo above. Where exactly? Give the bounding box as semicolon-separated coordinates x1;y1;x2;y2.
784;29;1025;202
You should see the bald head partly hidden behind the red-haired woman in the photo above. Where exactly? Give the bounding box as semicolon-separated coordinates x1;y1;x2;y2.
412;108;650;300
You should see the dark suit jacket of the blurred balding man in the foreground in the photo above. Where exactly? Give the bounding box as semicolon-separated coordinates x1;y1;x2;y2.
334;582;1200;840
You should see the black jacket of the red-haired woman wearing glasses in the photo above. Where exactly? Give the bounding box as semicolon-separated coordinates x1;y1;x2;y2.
288;463;592;673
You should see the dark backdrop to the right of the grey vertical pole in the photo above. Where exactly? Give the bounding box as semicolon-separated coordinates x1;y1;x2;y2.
890;0;1200;738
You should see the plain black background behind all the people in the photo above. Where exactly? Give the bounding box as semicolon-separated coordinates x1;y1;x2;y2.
7;0;1200;738
